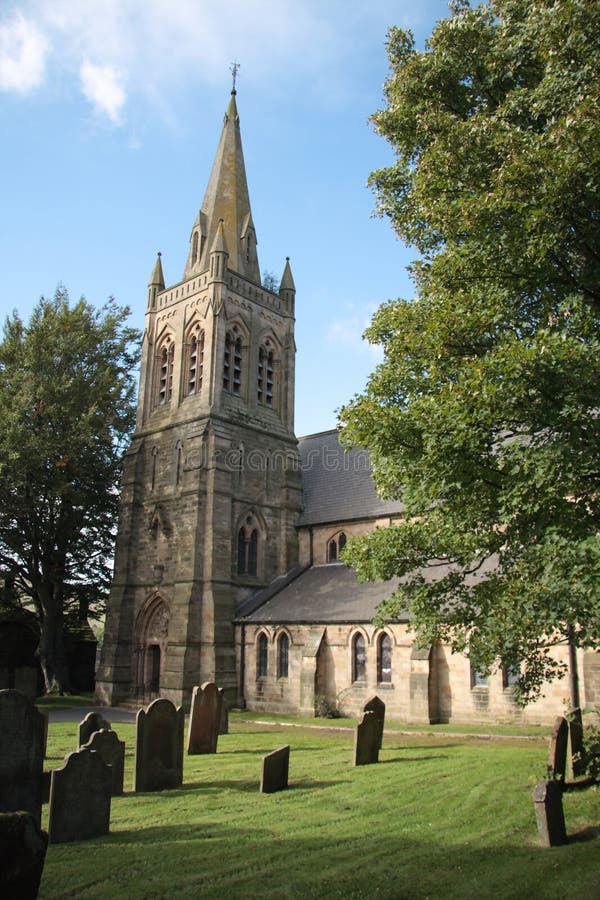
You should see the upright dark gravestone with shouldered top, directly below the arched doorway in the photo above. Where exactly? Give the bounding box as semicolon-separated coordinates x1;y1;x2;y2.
133;697;184;791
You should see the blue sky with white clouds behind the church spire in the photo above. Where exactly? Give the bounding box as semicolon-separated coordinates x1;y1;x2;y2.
0;0;448;436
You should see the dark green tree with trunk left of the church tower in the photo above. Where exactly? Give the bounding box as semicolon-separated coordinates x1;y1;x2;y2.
0;289;139;692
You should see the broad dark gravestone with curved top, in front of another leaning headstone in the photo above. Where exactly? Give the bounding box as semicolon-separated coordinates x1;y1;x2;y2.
48;749;112;844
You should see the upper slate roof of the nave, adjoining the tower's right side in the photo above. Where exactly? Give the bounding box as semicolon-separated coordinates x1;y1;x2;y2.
298;430;403;525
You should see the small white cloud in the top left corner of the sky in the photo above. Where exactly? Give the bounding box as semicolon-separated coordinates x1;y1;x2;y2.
0;15;48;94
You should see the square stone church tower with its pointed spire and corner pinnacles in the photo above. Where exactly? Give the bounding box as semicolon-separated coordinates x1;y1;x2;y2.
96;88;301;704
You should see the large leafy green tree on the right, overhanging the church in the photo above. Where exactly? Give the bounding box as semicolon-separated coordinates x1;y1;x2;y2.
340;0;600;703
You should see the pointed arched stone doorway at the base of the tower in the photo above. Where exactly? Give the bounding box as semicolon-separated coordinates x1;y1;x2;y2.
136;597;169;703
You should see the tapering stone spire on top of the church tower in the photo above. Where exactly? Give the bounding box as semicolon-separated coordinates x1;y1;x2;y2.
183;83;260;284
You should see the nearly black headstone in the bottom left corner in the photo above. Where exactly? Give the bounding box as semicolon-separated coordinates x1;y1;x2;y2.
0;812;48;900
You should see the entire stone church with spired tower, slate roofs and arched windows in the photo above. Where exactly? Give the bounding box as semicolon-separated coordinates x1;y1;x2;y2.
96;89;600;723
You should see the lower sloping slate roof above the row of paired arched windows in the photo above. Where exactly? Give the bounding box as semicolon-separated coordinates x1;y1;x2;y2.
236;563;408;624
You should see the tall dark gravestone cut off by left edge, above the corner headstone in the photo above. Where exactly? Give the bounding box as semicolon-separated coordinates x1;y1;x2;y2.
0;689;46;826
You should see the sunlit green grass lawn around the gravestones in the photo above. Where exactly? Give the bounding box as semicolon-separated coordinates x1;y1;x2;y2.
39;711;600;900
